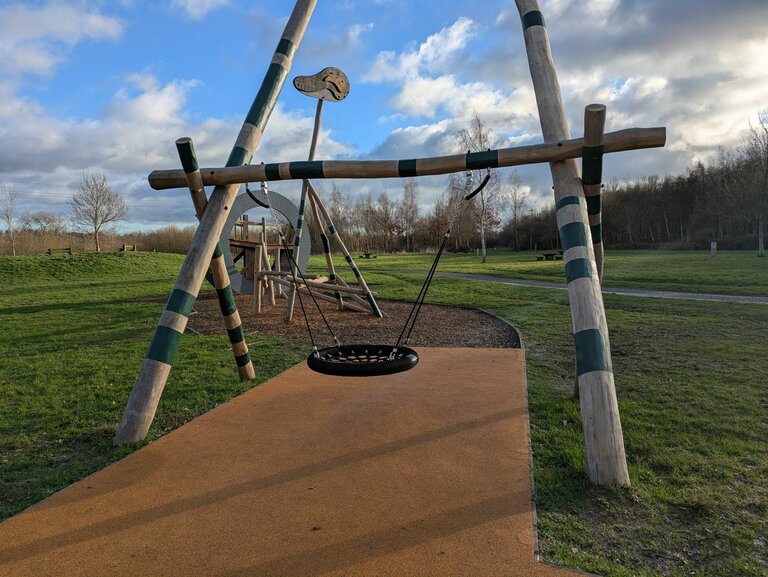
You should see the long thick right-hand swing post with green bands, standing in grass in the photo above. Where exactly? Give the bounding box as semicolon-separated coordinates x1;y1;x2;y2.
515;0;629;485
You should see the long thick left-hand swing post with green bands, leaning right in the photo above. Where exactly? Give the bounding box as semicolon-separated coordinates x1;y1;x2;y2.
115;0;316;443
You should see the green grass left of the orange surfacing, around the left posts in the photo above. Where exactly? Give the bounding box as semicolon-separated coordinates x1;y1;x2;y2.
0;253;306;519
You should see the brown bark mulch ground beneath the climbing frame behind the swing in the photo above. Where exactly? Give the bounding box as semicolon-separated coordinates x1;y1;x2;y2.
187;292;520;348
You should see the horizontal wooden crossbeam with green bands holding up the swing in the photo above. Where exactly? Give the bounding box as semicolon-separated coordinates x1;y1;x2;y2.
149;127;667;190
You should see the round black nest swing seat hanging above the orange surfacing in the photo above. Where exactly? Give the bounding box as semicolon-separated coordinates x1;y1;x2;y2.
307;345;419;377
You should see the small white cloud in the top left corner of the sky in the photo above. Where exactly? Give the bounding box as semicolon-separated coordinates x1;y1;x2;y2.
0;4;123;75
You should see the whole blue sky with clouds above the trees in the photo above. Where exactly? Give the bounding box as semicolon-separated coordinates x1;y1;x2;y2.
0;0;768;231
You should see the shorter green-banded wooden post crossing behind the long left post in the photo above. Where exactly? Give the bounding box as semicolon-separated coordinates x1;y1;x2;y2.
176;138;256;381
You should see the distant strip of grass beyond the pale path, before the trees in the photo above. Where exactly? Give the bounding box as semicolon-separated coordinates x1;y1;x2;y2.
332;250;768;296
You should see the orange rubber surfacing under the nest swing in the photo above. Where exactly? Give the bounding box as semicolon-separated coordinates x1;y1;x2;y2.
0;349;588;577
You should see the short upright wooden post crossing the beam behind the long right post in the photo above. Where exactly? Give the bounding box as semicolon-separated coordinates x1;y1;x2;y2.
581;104;605;282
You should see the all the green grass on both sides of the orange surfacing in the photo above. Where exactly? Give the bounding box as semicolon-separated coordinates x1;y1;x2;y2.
0;252;768;576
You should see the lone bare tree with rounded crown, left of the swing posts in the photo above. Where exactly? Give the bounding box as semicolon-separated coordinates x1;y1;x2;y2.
72;170;128;252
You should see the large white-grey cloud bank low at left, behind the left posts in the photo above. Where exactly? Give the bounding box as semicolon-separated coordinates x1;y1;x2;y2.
0;73;353;224
